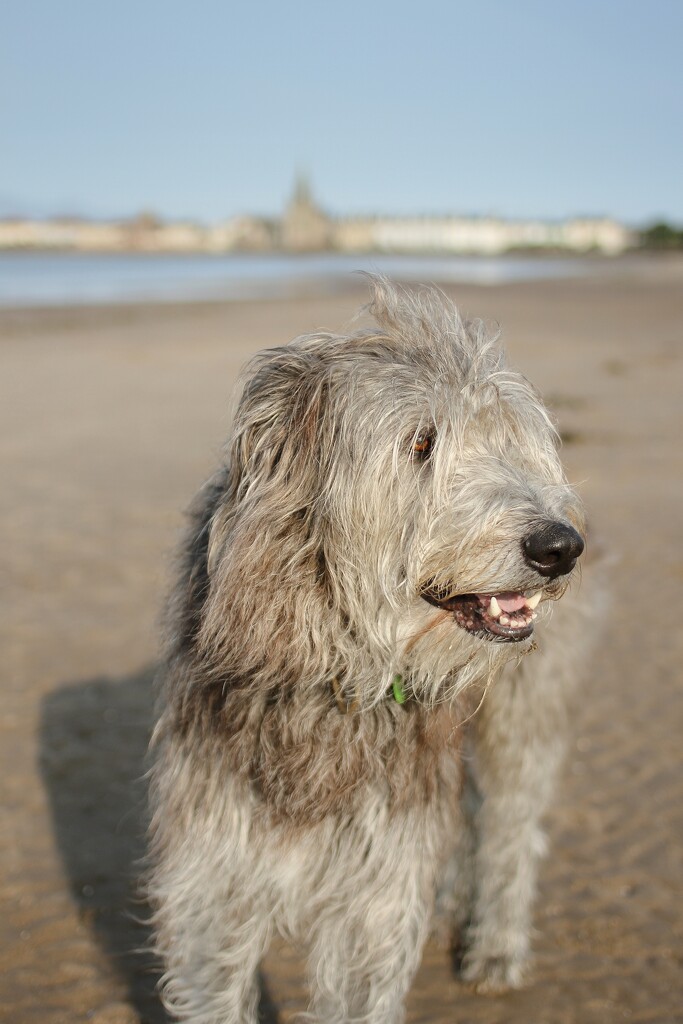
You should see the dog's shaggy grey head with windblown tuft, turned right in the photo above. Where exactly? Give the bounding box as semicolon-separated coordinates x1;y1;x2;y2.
203;281;584;700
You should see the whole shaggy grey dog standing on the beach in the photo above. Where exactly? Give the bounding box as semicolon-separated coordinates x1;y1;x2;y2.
151;281;594;1024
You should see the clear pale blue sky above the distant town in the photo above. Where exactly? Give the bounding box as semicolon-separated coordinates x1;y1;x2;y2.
0;0;683;225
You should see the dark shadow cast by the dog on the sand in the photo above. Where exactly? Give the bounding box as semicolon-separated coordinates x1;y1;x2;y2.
40;667;278;1024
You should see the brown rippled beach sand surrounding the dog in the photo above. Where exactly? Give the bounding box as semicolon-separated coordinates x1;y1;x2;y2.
0;261;683;1024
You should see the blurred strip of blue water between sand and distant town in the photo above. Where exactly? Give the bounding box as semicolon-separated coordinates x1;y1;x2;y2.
0;252;591;307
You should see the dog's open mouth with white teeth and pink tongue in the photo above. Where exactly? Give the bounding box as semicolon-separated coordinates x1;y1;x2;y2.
422;587;543;643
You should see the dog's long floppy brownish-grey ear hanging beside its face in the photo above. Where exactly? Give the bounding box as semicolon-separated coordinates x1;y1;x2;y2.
202;348;328;671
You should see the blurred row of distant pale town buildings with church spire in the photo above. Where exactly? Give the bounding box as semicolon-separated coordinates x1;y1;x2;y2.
0;177;640;256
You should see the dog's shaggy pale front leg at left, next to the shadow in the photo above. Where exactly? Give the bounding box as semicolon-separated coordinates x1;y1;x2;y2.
150;770;272;1024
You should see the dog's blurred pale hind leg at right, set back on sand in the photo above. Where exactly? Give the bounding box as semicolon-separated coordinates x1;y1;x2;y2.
462;587;602;991
